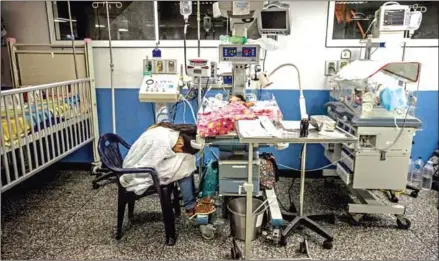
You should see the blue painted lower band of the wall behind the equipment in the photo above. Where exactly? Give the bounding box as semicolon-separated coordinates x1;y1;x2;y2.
64;89;439;168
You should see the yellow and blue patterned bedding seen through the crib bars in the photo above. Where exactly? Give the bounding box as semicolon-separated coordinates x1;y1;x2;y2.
2;96;85;147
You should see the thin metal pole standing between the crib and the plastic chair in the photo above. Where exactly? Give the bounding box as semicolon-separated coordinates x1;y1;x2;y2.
92;1;122;133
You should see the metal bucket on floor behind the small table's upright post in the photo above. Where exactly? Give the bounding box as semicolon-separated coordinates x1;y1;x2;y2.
227;197;266;240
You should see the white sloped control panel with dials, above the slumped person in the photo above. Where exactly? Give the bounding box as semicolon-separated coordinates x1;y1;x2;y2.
139;75;179;102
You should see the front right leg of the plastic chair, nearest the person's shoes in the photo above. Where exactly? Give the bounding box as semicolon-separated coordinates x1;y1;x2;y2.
160;186;177;246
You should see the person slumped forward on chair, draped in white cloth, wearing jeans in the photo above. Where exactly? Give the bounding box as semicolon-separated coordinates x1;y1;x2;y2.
120;122;215;216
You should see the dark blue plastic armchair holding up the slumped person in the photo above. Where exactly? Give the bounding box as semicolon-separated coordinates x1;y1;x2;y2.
98;133;181;246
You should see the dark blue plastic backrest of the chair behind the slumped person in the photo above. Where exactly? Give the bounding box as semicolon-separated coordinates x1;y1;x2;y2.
98;133;131;172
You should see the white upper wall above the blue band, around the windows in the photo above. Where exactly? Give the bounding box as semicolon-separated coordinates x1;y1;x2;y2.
2;1;438;90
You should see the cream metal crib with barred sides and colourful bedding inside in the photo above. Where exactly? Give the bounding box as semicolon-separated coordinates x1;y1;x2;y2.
0;39;99;193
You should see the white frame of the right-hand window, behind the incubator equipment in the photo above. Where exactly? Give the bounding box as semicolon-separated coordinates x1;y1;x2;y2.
325;1;439;48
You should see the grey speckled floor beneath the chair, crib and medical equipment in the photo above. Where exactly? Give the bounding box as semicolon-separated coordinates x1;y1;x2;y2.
1;169;438;260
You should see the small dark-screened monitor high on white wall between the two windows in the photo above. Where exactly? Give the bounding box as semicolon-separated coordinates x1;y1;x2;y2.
258;2;290;35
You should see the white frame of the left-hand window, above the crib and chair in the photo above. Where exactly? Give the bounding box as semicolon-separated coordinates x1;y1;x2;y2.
46;0;220;48
